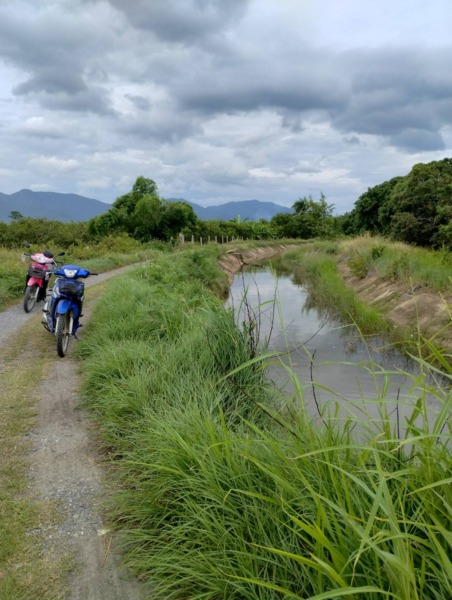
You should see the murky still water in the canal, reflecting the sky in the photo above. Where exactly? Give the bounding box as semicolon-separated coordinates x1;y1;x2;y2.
227;267;441;437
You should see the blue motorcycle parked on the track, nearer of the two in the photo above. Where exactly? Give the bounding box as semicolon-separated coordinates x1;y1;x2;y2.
42;265;97;357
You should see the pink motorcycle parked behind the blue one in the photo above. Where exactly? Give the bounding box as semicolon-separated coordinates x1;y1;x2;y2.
22;242;64;312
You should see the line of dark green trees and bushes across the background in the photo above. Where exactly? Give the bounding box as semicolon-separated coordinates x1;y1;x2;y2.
0;158;452;250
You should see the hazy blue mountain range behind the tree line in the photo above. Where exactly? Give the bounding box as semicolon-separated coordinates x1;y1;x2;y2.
0;189;292;223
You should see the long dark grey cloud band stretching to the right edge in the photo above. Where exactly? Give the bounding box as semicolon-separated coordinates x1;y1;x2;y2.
147;39;452;151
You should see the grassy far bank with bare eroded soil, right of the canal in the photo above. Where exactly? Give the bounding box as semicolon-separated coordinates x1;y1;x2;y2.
272;236;452;354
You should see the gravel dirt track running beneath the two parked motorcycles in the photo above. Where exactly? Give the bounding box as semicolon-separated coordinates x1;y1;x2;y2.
0;267;150;600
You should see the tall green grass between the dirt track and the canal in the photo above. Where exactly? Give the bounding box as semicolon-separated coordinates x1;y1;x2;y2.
79;248;452;600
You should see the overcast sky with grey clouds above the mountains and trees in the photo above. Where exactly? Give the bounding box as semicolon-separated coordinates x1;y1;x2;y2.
0;0;452;214
